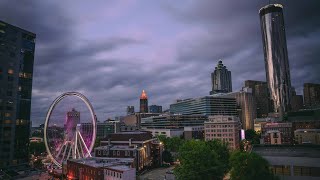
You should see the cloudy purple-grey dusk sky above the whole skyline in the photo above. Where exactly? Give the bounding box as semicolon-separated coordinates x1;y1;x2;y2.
0;0;320;126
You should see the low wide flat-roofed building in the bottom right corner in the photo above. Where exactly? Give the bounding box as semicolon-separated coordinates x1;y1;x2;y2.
252;145;320;180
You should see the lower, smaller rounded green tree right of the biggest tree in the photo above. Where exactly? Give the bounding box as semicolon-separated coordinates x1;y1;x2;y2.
230;151;278;180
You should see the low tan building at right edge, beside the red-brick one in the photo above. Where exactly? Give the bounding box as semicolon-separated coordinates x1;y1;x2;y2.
294;129;320;145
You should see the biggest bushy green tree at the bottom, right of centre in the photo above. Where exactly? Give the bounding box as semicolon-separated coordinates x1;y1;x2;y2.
174;140;224;180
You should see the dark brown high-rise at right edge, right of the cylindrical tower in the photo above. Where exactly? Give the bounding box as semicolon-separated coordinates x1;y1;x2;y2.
303;83;320;108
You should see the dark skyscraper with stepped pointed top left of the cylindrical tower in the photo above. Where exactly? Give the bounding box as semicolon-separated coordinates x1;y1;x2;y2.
210;61;232;94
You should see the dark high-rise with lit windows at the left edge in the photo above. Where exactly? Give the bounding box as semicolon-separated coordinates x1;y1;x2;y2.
0;21;36;168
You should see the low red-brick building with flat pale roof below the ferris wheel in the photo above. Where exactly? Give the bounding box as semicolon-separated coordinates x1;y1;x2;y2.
67;157;136;180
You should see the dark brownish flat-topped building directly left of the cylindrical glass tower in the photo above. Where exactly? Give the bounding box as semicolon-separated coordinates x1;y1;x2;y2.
244;80;270;118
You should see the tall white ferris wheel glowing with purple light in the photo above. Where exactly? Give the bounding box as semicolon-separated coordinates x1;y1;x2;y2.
44;92;96;168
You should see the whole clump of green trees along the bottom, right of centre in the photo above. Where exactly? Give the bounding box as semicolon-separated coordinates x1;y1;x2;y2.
158;135;278;180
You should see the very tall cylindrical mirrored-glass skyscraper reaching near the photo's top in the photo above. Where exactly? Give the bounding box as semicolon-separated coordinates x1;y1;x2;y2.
259;4;291;117
